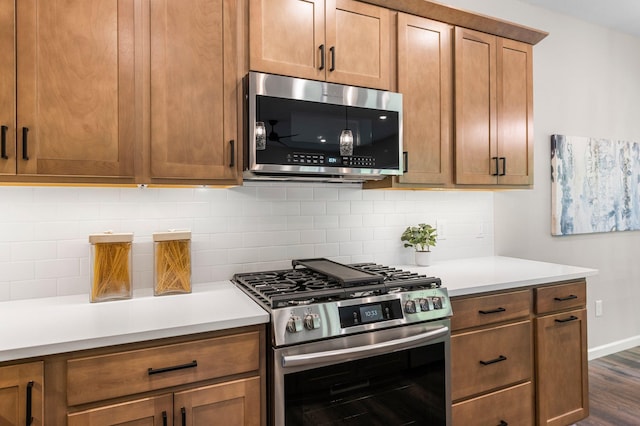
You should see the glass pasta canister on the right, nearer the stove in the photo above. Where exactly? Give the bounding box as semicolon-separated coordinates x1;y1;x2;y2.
153;231;191;296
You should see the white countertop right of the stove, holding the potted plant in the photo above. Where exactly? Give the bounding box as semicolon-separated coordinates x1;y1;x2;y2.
398;256;598;297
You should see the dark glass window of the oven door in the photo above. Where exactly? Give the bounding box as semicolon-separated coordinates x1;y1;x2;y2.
285;343;447;426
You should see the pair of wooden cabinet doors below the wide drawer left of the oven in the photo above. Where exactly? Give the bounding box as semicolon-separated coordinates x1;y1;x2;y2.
67;377;260;426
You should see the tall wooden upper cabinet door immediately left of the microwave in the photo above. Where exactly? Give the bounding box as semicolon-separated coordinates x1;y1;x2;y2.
150;0;241;182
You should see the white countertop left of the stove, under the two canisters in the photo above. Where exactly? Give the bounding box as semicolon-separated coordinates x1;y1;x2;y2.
0;281;269;362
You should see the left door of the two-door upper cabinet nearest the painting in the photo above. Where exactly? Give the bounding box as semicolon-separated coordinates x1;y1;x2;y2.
455;27;499;185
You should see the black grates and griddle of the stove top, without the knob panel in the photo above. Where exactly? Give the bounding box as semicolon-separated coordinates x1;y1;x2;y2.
234;259;441;309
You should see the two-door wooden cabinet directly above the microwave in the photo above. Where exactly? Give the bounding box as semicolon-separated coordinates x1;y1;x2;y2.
249;0;392;90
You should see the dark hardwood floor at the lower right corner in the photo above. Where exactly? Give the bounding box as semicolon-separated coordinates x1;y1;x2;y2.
577;346;640;426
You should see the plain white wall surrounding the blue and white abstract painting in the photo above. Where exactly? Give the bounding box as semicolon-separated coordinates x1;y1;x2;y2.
446;0;640;357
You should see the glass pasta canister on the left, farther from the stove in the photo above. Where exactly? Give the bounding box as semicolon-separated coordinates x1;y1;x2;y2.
89;232;133;302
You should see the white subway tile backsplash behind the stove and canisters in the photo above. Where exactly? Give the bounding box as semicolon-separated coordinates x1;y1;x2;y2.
0;183;494;301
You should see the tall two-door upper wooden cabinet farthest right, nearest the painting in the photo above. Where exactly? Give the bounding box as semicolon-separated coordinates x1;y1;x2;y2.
455;28;533;185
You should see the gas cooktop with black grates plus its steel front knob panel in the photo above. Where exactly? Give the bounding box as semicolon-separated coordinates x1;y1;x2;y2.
233;259;452;347
